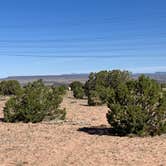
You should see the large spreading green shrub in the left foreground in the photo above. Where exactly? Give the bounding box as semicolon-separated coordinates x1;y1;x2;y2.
3;80;66;123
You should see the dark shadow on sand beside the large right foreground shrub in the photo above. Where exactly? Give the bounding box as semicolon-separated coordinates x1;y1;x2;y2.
78;125;124;136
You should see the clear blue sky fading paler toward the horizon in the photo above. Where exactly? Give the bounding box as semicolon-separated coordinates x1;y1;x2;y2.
0;0;166;77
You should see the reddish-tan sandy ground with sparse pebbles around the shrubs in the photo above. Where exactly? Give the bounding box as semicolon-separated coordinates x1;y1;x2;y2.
0;92;166;166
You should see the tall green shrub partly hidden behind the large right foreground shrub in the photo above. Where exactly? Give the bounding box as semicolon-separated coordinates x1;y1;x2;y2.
84;70;130;105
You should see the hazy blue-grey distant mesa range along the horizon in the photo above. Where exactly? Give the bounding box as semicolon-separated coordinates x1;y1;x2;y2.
1;72;166;85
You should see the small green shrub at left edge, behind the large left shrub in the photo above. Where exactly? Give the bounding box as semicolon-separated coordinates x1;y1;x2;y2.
0;80;22;96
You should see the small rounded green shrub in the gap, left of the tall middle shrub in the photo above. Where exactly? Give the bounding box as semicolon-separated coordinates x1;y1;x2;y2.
70;81;85;99
